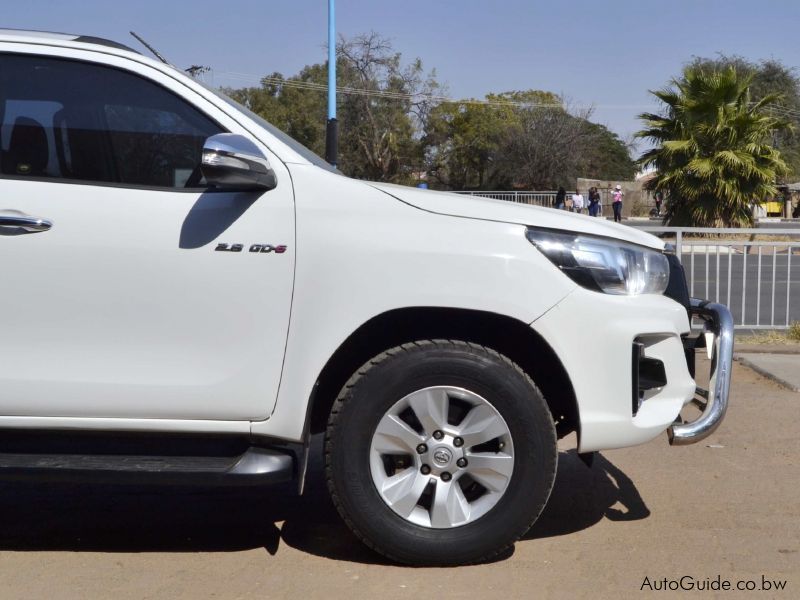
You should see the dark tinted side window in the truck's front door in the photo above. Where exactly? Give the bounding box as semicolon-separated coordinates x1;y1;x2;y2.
0;54;224;188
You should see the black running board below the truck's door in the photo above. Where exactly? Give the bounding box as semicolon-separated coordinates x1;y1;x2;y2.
0;446;295;486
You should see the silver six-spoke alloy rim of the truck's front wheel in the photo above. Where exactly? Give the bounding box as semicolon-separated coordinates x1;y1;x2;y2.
369;386;514;529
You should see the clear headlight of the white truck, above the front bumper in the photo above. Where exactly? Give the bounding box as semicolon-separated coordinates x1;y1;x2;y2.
526;228;669;296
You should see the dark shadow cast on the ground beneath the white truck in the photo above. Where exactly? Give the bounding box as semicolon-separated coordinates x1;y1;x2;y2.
0;452;649;563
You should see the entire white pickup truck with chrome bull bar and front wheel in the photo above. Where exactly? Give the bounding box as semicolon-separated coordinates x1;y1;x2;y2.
0;30;733;564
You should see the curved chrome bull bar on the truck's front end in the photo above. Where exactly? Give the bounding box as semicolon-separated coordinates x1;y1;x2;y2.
667;298;733;446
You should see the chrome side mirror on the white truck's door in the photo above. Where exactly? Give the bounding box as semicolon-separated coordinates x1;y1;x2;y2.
200;133;278;191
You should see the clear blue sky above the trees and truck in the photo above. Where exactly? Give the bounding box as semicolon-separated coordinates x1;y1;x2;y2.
6;0;800;150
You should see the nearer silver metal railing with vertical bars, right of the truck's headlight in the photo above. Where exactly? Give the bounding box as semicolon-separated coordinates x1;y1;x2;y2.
639;227;800;329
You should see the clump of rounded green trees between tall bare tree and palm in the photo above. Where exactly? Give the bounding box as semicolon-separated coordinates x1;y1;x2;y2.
424;90;636;189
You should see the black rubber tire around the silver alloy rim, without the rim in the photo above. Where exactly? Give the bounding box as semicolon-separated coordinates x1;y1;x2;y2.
325;340;557;565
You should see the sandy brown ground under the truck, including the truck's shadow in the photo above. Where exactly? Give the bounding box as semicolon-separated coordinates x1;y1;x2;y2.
0;364;800;600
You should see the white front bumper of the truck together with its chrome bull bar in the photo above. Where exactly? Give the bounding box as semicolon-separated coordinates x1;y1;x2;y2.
531;287;733;453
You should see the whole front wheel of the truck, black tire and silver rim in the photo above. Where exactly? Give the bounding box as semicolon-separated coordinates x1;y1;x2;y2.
325;340;557;565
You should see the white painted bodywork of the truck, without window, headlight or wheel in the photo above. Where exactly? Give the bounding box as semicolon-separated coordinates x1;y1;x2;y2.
0;32;732;452
